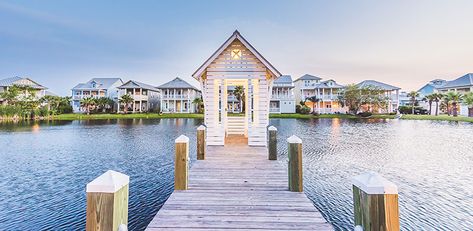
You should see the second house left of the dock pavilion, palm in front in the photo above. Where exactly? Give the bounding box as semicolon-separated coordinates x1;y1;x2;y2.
118;80;161;113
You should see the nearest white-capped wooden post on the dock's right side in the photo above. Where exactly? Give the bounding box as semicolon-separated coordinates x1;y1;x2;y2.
352;172;400;231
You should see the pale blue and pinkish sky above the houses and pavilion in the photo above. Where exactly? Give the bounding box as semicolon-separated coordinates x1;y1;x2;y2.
0;0;473;95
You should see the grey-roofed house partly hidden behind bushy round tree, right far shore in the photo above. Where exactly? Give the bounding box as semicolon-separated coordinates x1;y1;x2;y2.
357;80;401;113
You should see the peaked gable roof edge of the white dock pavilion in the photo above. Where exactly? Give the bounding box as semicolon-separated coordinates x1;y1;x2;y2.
192;30;281;80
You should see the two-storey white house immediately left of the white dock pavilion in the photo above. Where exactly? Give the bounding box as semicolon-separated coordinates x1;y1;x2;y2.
158;77;201;113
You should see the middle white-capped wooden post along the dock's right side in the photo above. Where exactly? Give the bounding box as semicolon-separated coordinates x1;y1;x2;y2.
287;135;303;192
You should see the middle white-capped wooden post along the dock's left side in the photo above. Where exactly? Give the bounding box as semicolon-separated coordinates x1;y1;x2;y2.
174;135;189;190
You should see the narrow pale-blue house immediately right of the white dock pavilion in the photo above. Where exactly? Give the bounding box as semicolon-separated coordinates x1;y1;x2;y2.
269;75;296;113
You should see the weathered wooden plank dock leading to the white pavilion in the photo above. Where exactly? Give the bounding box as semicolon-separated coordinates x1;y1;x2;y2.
146;142;333;230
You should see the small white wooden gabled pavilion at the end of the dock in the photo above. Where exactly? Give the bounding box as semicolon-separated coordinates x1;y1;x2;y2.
192;31;281;146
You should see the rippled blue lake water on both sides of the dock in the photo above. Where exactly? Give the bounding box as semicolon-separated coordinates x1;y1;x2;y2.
0;119;473;230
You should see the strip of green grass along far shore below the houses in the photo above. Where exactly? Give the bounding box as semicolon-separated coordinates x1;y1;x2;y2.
45;113;473;123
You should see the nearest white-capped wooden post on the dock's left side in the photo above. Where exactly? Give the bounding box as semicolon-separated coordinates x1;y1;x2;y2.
86;170;130;231
